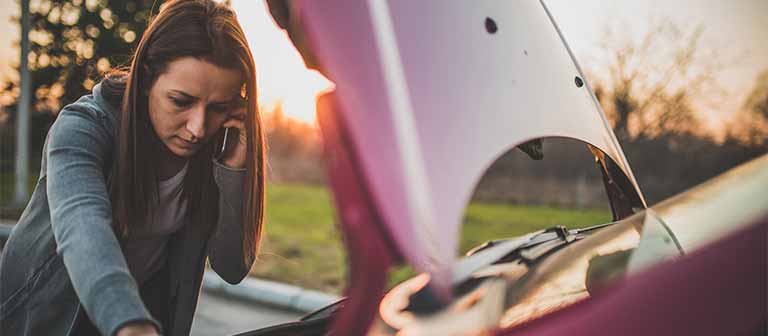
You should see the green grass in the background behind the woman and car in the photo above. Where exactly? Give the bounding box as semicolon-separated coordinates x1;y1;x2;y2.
252;184;611;294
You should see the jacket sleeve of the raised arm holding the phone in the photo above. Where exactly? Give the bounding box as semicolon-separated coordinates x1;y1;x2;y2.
208;160;254;284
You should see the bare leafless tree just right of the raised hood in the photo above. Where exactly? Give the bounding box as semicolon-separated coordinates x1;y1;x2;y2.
591;20;720;140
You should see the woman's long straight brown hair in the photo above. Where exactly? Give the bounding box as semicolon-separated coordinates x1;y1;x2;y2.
103;0;266;265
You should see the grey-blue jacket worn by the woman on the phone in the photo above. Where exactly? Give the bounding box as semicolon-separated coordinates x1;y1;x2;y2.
0;85;252;336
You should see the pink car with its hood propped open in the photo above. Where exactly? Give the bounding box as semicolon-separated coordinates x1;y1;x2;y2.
237;0;768;336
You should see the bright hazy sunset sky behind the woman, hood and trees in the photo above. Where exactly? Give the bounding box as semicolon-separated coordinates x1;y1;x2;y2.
0;0;768;127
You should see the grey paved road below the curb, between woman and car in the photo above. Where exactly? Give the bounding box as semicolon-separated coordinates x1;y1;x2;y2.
190;290;302;336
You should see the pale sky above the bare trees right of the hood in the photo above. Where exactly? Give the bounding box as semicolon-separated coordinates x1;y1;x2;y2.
545;0;768;131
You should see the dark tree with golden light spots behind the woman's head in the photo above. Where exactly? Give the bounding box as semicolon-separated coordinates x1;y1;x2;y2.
4;0;160;114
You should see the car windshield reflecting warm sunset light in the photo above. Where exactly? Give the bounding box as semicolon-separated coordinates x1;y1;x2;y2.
500;213;680;327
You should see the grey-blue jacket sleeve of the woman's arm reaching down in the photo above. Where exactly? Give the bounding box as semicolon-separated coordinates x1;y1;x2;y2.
45;105;160;335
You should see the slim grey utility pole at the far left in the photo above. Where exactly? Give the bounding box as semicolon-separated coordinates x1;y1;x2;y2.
13;0;32;205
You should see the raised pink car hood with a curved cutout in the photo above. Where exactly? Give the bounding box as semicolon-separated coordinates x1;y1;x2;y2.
268;0;645;289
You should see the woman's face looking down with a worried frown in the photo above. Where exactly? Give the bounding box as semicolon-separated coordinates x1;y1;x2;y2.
148;57;243;157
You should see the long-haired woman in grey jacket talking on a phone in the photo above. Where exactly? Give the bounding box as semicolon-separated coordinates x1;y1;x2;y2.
0;0;265;336
